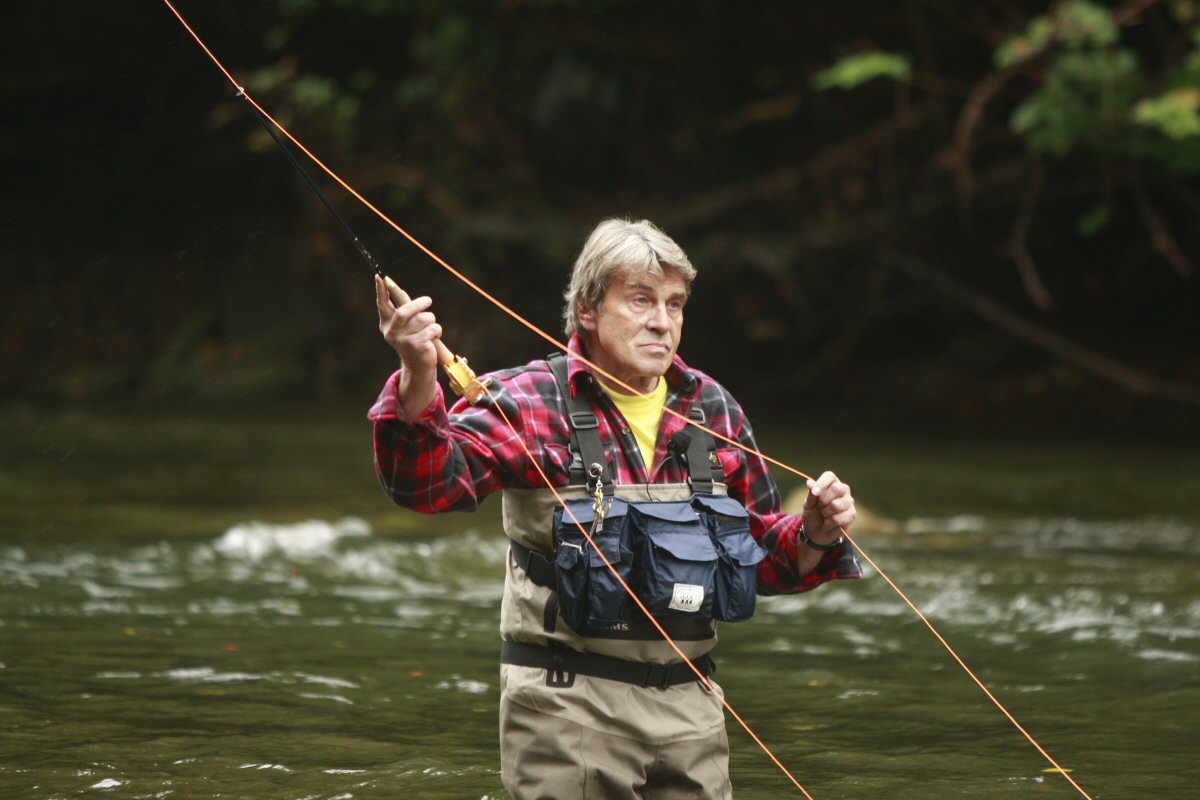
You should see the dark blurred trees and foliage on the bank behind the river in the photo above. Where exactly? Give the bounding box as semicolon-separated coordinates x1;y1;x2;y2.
0;0;1200;429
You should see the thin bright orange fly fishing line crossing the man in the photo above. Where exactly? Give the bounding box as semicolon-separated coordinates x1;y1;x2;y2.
163;0;1093;800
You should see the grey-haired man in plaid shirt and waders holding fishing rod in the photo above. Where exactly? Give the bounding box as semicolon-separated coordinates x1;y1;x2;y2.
370;219;862;800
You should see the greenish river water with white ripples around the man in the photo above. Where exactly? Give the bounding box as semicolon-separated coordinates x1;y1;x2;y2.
0;409;1200;800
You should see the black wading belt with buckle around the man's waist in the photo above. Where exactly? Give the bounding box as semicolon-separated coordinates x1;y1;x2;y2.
500;642;716;688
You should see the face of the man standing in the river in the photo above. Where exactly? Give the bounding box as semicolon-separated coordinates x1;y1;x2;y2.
580;269;688;392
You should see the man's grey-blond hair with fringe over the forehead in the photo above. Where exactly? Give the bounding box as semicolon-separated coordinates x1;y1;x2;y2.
563;218;696;336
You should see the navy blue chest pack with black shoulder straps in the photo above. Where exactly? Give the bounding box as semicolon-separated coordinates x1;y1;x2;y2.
548;354;766;634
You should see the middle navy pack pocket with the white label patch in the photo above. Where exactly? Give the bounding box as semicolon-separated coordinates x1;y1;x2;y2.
629;501;716;619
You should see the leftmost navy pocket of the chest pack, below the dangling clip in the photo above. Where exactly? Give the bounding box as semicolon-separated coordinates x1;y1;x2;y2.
554;500;634;631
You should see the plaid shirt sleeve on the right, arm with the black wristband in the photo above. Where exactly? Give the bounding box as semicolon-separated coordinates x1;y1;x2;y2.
697;373;863;595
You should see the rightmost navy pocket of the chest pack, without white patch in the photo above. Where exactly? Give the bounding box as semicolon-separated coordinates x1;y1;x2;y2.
692;494;767;622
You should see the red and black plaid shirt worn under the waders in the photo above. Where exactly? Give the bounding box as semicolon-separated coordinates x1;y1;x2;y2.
368;337;863;595
